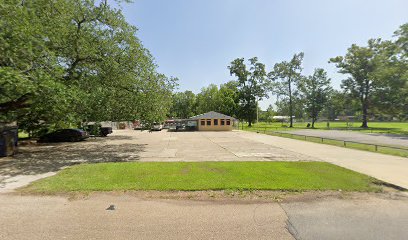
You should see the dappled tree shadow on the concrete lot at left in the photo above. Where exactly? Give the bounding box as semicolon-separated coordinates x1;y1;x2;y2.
0;136;145;181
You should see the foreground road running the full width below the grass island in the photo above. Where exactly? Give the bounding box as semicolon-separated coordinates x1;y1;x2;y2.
0;193;408;240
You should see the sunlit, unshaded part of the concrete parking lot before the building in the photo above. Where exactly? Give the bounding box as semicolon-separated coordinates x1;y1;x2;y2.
136;131;313;161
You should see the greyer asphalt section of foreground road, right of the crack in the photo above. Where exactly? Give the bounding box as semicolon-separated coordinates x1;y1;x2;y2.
283;195;408;240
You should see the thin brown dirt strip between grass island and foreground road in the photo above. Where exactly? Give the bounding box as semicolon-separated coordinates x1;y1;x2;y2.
12;189;408;203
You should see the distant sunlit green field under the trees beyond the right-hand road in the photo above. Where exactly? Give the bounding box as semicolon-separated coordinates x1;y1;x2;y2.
240;121;408;135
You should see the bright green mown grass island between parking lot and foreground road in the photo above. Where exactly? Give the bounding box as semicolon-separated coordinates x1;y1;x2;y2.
21;162;381;194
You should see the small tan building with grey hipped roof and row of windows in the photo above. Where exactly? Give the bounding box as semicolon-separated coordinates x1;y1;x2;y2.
190;111;236;131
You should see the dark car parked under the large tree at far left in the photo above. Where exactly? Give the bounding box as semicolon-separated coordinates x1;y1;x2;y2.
38;129;89;142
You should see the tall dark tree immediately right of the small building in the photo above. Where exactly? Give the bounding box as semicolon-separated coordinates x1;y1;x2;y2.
228;57;270;127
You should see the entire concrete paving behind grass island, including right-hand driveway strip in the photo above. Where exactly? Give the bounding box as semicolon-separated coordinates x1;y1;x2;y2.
0;130;408;192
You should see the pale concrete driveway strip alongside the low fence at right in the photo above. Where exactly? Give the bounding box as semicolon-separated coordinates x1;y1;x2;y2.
237;132;408;189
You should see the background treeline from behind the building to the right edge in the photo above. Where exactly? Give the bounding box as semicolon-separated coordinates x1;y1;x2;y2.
169;24;408;127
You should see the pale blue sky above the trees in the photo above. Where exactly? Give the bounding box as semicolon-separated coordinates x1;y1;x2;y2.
118;0;408;109
